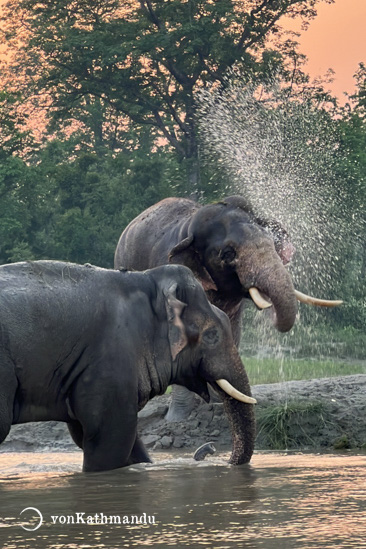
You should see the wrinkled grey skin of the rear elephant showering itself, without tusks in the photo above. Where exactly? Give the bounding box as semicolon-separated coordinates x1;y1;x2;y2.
115;196;297;421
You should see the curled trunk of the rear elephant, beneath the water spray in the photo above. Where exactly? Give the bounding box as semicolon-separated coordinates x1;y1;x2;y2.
238;249;297;332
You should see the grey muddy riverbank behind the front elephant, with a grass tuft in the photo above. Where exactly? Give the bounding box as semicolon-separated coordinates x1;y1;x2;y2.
0;375;366;452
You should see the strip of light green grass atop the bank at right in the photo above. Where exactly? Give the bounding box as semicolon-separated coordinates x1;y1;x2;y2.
242;356;366;385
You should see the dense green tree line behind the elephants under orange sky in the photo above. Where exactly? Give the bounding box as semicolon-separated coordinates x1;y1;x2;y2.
0;0;366;328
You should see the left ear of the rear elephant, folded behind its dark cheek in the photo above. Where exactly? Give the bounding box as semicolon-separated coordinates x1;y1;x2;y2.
169;236;217;292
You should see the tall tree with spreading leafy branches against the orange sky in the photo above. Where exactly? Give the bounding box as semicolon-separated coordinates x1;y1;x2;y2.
0;0;332;189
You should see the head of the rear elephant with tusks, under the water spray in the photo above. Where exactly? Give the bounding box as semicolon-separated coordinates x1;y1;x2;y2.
169;196;339;332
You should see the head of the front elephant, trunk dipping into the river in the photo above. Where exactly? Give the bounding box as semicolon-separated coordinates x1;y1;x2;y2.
150;266;256;464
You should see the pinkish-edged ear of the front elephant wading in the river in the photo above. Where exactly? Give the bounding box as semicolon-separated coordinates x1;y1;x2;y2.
163;284;188;360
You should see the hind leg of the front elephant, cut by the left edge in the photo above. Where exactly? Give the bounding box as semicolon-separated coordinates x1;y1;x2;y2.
0;357;18;443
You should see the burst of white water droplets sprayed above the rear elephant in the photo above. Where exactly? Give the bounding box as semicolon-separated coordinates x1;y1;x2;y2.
198;73;364;370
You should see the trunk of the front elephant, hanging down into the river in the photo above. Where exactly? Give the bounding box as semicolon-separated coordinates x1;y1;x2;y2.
207;346;256;465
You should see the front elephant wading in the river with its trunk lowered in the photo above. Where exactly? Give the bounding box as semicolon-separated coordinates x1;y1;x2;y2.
0;260;255;472
